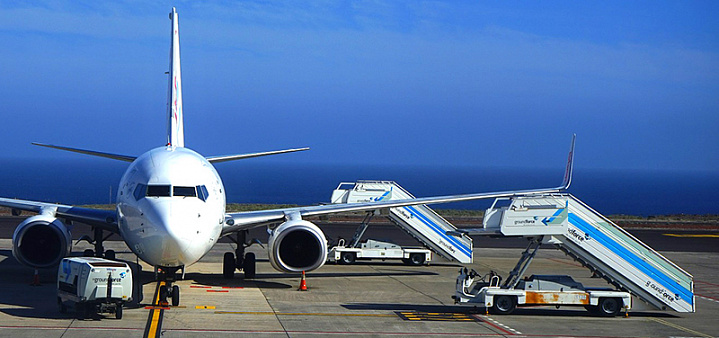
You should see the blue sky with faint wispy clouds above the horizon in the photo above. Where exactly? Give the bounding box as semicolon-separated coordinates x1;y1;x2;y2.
0;1;719;172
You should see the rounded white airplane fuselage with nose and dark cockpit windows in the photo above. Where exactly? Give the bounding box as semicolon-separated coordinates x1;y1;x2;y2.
117;146;225;267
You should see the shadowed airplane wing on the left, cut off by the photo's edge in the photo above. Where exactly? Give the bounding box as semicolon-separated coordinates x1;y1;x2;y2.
0;198;119;233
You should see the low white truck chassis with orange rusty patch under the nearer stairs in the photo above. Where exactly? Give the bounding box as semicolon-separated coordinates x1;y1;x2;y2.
452;268;632;316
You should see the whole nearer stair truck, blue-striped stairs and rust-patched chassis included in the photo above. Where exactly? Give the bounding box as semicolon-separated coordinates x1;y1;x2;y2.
448;193;696;316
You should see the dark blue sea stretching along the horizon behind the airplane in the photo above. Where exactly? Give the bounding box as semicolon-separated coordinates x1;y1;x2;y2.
0;158;719;216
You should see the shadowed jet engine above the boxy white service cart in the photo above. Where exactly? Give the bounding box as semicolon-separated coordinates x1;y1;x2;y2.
12;215;72;268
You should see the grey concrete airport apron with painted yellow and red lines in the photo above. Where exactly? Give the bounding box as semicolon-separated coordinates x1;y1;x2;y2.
0;234;719;337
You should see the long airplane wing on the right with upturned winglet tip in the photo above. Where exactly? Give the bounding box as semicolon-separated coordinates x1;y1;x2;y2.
222;135;576;235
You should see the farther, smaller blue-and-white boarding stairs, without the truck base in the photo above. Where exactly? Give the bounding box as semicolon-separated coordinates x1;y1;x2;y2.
331;181;472;264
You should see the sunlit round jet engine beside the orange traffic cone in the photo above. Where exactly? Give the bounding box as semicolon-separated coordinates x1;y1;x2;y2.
267;220;327;272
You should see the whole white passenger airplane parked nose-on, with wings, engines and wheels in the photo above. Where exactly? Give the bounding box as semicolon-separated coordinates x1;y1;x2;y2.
0;7;576;306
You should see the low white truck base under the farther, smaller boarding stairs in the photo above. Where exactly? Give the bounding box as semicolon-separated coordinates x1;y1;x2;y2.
328;239;432;265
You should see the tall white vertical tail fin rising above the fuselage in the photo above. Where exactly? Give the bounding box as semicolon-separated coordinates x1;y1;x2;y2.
167;7;185;147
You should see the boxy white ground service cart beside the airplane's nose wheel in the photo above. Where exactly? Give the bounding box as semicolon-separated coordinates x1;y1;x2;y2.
57;257;133;319
